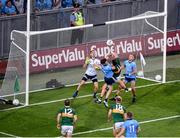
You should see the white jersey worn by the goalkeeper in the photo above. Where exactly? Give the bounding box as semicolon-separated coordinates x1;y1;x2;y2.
85;58;100;76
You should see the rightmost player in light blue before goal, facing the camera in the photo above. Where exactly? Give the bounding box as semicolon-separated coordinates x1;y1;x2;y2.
122;54;137;103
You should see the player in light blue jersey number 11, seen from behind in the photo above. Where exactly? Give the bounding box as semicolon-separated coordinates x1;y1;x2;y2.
117;112;140;138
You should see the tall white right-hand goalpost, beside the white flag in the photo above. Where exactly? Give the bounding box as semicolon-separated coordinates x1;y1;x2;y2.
162;0;168;83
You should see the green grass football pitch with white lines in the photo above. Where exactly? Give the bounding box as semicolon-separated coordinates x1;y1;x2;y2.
0;79;180;137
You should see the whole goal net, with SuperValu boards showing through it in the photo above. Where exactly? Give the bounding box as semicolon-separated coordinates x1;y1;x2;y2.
0;5;170;107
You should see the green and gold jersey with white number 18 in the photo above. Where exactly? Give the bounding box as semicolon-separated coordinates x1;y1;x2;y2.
111;104;126;123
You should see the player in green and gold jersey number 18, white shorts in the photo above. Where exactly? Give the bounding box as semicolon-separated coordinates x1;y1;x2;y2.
108;96;126;137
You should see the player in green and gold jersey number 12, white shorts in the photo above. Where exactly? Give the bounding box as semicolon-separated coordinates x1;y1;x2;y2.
57;99;77;138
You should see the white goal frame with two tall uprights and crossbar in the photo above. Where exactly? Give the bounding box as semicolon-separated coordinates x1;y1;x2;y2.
11;0;168;106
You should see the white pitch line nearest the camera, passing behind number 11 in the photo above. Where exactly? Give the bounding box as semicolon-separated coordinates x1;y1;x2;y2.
73;115;180;136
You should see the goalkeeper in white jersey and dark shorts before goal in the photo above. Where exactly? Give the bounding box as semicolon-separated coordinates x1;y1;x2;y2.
73;49;100;99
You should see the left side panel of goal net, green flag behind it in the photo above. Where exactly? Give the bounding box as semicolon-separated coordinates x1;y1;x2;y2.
0;33;26;105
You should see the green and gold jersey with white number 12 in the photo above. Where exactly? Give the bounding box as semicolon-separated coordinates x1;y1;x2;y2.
59;107;76;126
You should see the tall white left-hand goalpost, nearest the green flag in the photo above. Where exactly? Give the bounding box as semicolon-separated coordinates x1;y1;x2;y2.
25;0;31;106
